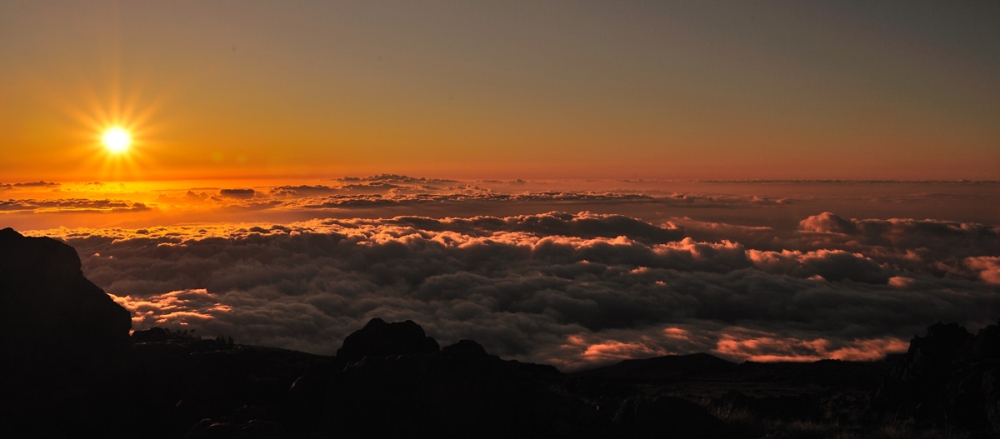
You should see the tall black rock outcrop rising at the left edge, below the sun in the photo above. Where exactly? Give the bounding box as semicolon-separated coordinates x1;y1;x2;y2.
0;228;132;369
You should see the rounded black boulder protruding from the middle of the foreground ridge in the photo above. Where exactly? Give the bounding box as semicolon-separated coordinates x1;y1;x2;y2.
337;318;440;363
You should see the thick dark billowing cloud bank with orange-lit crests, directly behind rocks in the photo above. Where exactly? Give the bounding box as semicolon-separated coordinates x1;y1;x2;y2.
45;212;1000;369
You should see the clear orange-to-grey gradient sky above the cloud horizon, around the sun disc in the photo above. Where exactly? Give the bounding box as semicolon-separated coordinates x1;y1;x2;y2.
0;0;1000;183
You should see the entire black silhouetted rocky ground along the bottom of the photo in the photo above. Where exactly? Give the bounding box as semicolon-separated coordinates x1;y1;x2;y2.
0;229;1000;438
